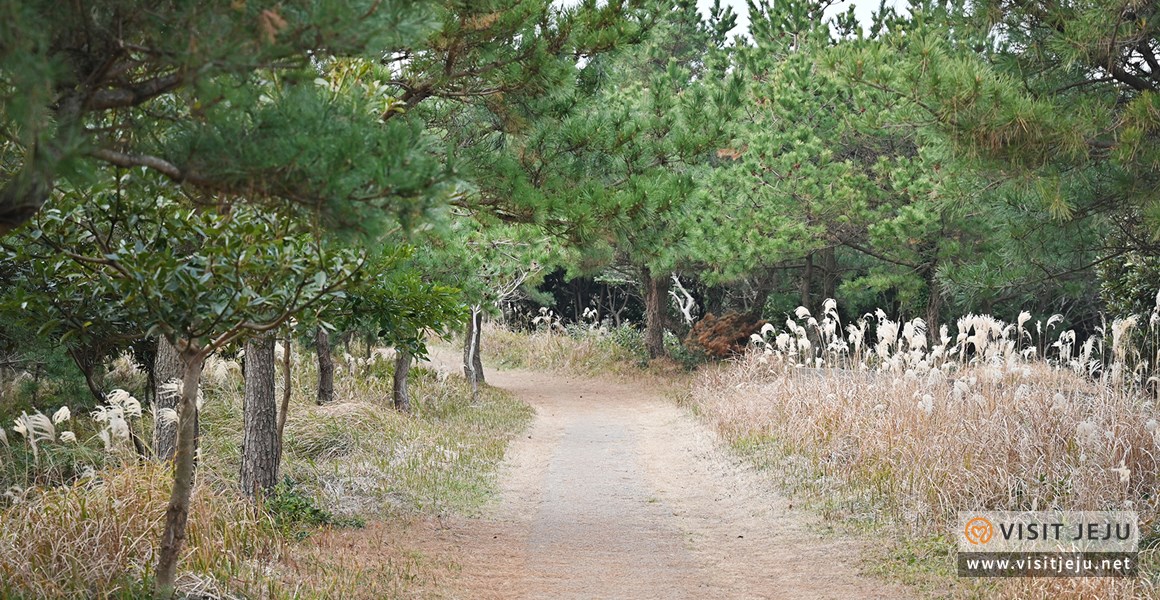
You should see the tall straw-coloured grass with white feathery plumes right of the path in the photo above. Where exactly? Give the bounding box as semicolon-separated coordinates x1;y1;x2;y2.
691;301;1160;598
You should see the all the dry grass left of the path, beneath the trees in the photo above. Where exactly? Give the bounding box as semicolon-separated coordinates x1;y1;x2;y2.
0;338;531;599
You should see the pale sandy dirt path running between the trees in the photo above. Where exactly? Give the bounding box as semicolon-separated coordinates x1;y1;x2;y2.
416;356;908;599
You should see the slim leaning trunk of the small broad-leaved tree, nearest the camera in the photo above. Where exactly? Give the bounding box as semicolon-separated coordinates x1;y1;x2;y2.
155;342;205;598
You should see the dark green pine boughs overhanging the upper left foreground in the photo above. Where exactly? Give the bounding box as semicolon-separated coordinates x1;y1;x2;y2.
0;0;437;234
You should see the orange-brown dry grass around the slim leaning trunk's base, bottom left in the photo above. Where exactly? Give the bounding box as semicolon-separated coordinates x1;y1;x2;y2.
0;464;273;598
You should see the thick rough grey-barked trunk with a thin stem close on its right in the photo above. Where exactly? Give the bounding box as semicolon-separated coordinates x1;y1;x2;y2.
241;334;282;499
